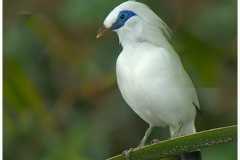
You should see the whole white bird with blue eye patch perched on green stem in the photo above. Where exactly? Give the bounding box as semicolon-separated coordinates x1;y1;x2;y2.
97;1;201;160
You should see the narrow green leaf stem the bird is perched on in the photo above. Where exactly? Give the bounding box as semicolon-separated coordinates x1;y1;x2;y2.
108;125;237;160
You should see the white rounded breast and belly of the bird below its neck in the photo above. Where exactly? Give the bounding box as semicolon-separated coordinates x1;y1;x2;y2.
116;46;194;126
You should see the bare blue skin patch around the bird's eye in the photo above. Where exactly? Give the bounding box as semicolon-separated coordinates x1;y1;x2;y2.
110;10;136;30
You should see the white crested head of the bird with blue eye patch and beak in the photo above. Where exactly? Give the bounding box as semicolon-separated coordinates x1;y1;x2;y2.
97;1;171;47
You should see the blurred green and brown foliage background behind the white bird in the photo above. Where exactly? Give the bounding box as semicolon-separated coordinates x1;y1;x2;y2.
3;0;237;160
